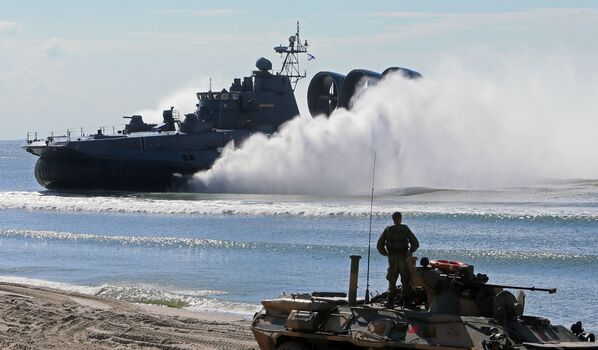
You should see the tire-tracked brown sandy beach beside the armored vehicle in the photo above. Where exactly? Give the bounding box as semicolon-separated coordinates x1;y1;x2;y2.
0;283;257;350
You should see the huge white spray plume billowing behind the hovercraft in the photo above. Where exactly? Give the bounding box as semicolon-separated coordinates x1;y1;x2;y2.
195;57;598;194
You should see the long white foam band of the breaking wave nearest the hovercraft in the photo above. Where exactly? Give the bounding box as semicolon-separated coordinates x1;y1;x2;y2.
0;192;598;220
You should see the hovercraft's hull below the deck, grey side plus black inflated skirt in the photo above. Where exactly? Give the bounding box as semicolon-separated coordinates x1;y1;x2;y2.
24;137;220;192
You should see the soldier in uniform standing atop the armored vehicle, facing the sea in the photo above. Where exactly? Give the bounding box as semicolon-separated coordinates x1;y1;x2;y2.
376;211;419;307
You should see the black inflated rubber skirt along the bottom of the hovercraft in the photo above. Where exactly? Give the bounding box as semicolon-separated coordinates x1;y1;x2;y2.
35;157;201;192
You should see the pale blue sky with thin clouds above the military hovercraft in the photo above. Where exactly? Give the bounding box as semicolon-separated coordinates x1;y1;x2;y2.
0;0;598;139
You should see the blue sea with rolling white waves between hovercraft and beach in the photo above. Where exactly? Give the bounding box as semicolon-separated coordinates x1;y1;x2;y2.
0;141;598;332
